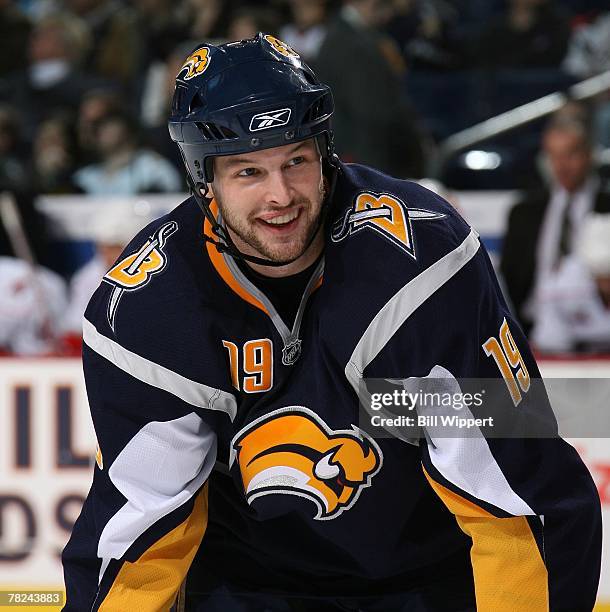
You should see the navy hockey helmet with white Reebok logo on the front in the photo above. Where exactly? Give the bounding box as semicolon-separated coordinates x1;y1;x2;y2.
169;33;334;192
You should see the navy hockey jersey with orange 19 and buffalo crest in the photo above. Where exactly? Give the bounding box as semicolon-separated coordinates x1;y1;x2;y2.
63;165;601;612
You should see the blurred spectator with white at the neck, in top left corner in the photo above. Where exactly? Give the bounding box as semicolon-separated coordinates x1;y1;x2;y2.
9;13;100;142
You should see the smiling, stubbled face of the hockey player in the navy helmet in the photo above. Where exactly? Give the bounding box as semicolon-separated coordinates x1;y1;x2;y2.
210;140;324;272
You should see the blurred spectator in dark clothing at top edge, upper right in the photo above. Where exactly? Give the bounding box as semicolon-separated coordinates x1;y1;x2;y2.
472;0;570;69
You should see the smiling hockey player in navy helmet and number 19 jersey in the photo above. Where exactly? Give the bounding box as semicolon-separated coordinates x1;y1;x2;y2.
63;34;601;612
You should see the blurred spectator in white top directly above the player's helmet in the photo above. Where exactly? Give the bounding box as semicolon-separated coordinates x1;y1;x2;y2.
279;0;328;62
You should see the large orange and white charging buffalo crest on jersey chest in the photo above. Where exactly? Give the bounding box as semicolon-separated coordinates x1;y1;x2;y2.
230;406;383;520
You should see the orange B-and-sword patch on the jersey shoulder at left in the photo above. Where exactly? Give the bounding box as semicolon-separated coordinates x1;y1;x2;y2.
102;221;178;329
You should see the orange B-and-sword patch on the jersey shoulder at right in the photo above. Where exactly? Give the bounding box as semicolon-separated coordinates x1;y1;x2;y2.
332;192;445;259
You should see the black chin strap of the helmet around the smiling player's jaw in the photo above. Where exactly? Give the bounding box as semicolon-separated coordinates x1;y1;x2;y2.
187;162;339;267
